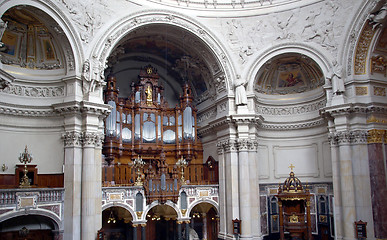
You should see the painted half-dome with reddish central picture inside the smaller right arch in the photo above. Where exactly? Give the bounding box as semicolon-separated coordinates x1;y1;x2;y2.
256;54;324;95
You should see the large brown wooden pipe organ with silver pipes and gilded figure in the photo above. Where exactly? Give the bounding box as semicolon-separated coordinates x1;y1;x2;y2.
102;65;208;203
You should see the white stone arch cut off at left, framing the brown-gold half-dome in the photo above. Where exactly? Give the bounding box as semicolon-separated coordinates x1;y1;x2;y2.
0;0;83;75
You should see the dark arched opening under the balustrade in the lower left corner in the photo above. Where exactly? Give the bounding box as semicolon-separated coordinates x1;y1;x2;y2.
0;215;59;240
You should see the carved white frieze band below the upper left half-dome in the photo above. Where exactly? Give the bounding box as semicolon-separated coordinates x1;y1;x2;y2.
0;84;65;98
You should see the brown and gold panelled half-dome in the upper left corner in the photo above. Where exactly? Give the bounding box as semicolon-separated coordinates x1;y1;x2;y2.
1;7;65;70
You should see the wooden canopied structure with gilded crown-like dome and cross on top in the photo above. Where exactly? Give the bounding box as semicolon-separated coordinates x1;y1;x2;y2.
277;171;312;240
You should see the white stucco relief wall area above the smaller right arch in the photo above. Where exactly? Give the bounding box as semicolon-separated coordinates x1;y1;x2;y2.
221;0;352;64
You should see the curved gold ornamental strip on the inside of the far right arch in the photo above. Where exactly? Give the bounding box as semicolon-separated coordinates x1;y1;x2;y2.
354;21;375;75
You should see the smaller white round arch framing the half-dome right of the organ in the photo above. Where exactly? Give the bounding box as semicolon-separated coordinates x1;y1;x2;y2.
243;43;333;92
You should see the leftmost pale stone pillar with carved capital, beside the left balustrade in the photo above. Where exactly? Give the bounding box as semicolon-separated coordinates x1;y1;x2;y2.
63;131;82;240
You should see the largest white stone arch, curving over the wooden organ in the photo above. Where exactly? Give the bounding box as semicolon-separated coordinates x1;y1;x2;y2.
90;11;235;97
